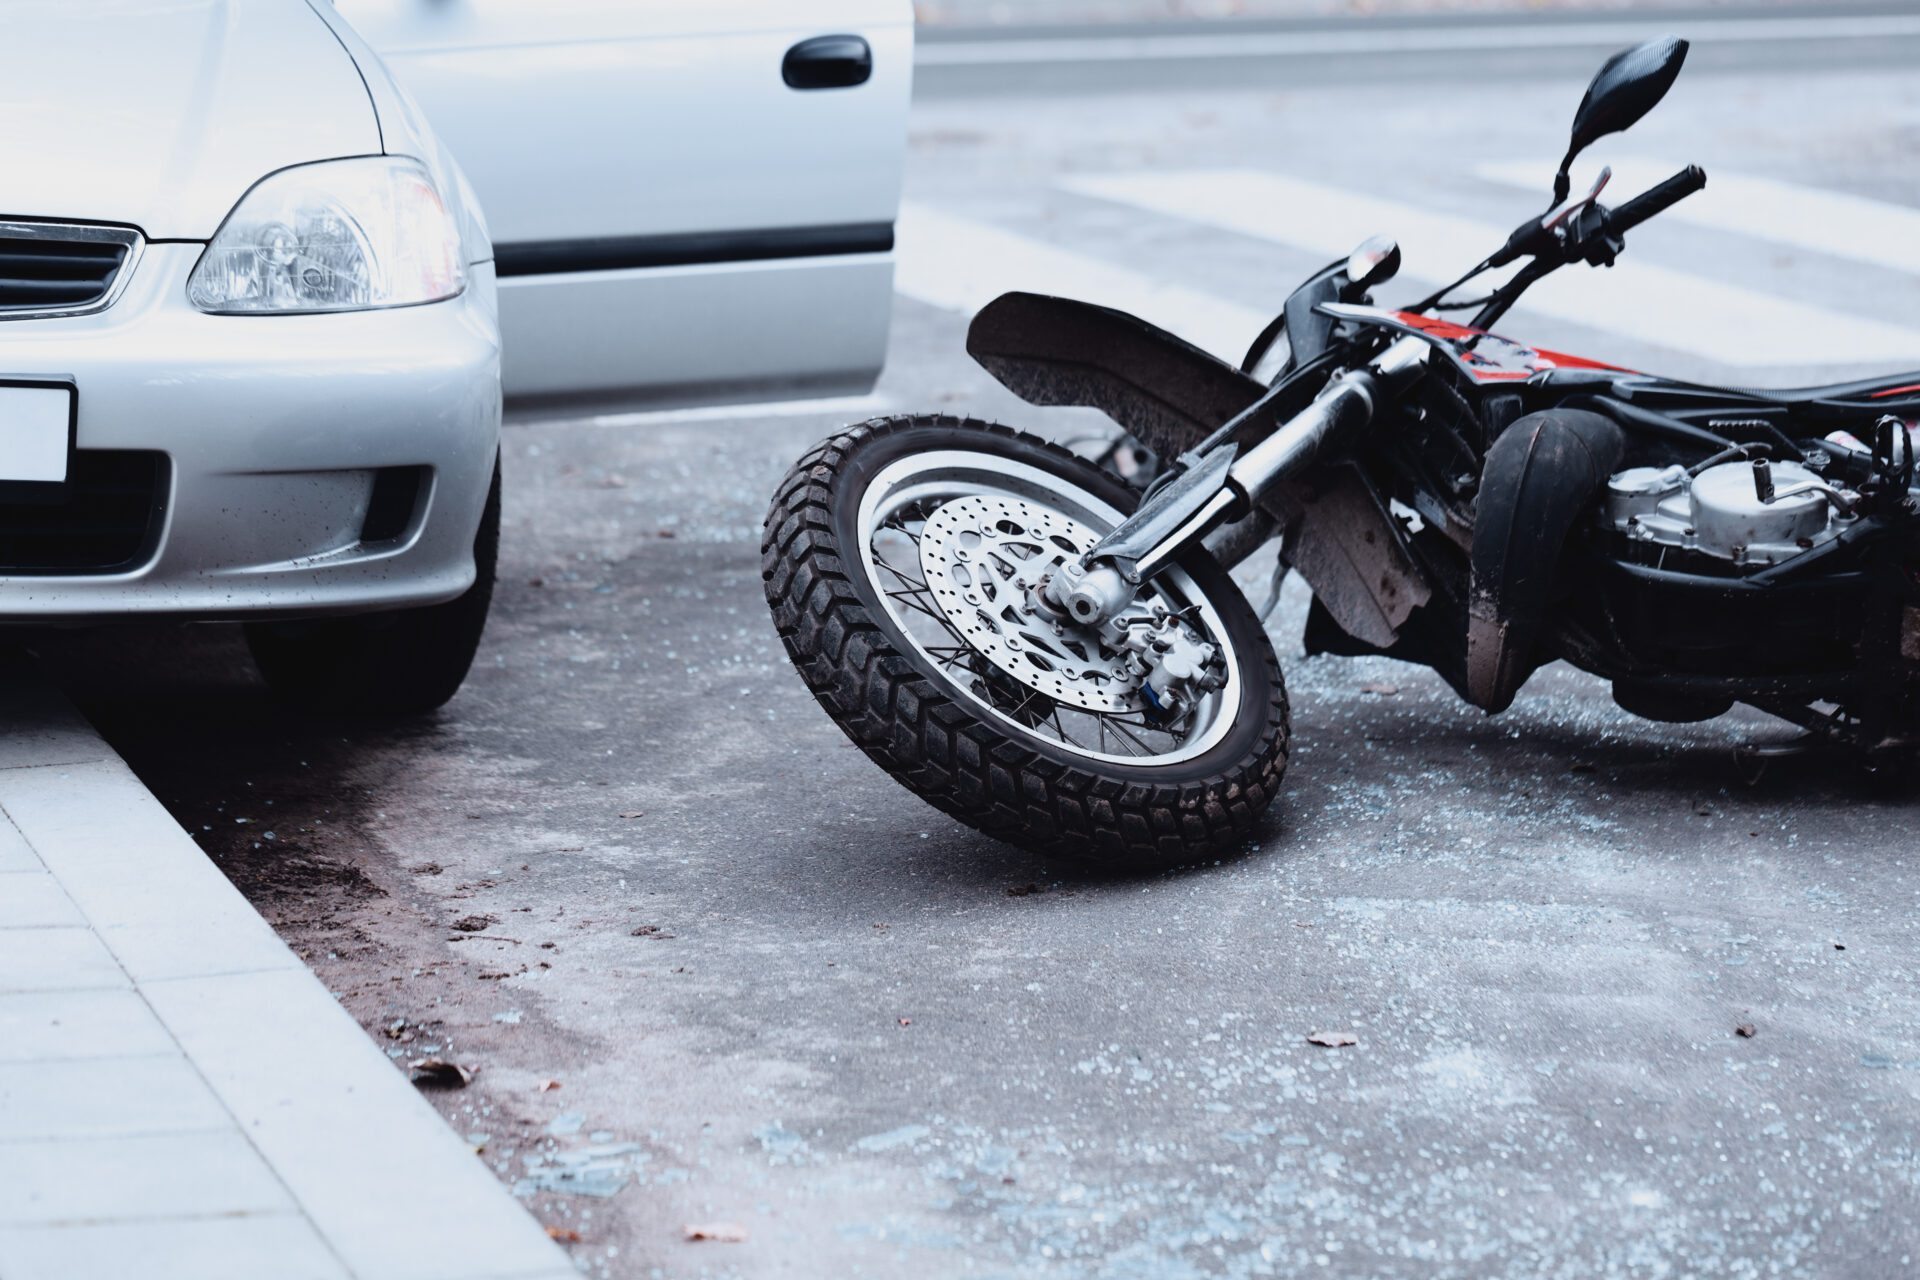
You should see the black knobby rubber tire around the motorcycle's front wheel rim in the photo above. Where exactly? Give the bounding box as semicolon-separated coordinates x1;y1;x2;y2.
760;415;1290;869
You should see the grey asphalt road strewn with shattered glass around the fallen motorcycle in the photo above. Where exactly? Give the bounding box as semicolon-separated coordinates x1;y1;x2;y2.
40;12;1920;1280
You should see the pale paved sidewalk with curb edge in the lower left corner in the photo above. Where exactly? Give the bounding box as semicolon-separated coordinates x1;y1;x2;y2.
0;658;578;1280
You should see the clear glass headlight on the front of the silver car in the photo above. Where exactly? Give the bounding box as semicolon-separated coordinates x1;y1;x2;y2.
186;155;467;315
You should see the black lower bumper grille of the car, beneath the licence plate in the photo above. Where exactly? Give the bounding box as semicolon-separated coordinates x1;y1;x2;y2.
0;449;167;578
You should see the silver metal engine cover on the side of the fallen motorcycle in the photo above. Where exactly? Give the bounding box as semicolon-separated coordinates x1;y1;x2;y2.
1605;454;1845;566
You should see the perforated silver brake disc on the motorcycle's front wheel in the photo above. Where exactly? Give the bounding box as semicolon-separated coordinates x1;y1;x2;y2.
920;497;1140;712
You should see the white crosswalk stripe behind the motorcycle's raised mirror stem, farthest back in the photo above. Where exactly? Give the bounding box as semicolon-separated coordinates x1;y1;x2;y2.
1473;155;1920;274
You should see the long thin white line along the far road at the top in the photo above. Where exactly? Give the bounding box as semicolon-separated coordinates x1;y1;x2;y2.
914;13;1920;67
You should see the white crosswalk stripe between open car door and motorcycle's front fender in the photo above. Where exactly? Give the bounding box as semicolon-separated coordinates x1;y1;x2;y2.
893;201;1279;363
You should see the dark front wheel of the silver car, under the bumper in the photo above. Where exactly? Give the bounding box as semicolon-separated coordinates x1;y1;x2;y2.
246;459;499;716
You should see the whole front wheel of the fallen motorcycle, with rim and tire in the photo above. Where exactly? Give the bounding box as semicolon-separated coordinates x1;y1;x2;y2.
760;415;1288;867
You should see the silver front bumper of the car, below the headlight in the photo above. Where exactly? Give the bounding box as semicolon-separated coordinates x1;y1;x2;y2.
0;244;499;622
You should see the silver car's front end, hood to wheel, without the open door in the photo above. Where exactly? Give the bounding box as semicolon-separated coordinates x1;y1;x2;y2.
0;0;501;712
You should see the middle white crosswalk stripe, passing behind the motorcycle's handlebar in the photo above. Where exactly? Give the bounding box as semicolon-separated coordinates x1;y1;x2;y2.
1062;169;1920;367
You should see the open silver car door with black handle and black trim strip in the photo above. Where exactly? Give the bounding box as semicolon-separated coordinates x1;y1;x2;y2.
338;0;914;399
